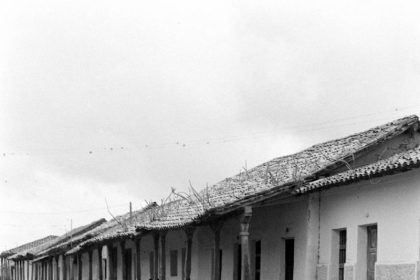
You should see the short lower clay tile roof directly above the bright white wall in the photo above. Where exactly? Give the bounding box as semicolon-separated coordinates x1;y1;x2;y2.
296;147;420;193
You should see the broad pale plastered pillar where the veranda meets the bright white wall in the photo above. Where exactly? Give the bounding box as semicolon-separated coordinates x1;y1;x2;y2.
304;192;320;279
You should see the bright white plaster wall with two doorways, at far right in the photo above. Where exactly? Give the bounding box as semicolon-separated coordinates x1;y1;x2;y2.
320;170;420;280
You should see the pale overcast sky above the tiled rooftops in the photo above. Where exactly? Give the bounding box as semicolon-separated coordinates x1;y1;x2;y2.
0;0;420;251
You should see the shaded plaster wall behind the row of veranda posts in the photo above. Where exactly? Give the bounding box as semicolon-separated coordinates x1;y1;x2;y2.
83;197;307;280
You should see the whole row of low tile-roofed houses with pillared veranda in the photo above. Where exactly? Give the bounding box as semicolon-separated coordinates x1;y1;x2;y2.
0;116;420;280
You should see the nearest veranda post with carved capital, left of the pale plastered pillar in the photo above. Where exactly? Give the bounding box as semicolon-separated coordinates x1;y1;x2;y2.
239;206;252;280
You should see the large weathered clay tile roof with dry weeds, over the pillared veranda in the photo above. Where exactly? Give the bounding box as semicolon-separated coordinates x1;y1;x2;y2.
130;115;418;231
